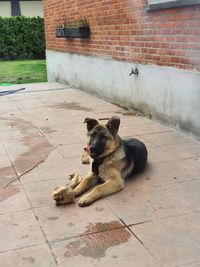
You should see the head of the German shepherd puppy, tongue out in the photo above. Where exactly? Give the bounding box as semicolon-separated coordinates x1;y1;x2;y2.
84;116;120;159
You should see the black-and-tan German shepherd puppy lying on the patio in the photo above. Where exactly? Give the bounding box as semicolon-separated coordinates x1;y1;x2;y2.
74;116;147;207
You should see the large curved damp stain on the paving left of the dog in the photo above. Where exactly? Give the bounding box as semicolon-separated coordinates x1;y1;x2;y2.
0;116;53;175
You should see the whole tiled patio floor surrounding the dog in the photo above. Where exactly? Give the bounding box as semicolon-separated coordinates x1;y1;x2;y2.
0;83;200;267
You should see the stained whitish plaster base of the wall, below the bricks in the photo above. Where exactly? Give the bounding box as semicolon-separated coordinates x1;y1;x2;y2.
46;50;200;136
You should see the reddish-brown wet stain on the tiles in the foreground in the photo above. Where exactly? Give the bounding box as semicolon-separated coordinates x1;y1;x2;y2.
64;221;131;259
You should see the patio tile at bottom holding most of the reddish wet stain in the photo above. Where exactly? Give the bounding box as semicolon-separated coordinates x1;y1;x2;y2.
52;227;161;267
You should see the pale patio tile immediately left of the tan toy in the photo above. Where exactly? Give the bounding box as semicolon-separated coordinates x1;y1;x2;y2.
23;178;68;207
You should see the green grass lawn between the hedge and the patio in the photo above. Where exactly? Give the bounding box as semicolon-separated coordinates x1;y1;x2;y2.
0;60;47;84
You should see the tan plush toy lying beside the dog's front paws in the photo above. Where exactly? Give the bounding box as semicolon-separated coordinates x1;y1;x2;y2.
52;173;81;205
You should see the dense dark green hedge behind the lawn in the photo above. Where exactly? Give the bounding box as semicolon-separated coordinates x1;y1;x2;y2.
0;17;45;60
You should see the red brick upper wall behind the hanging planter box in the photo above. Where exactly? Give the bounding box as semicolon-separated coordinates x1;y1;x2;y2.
44;0;200;70
